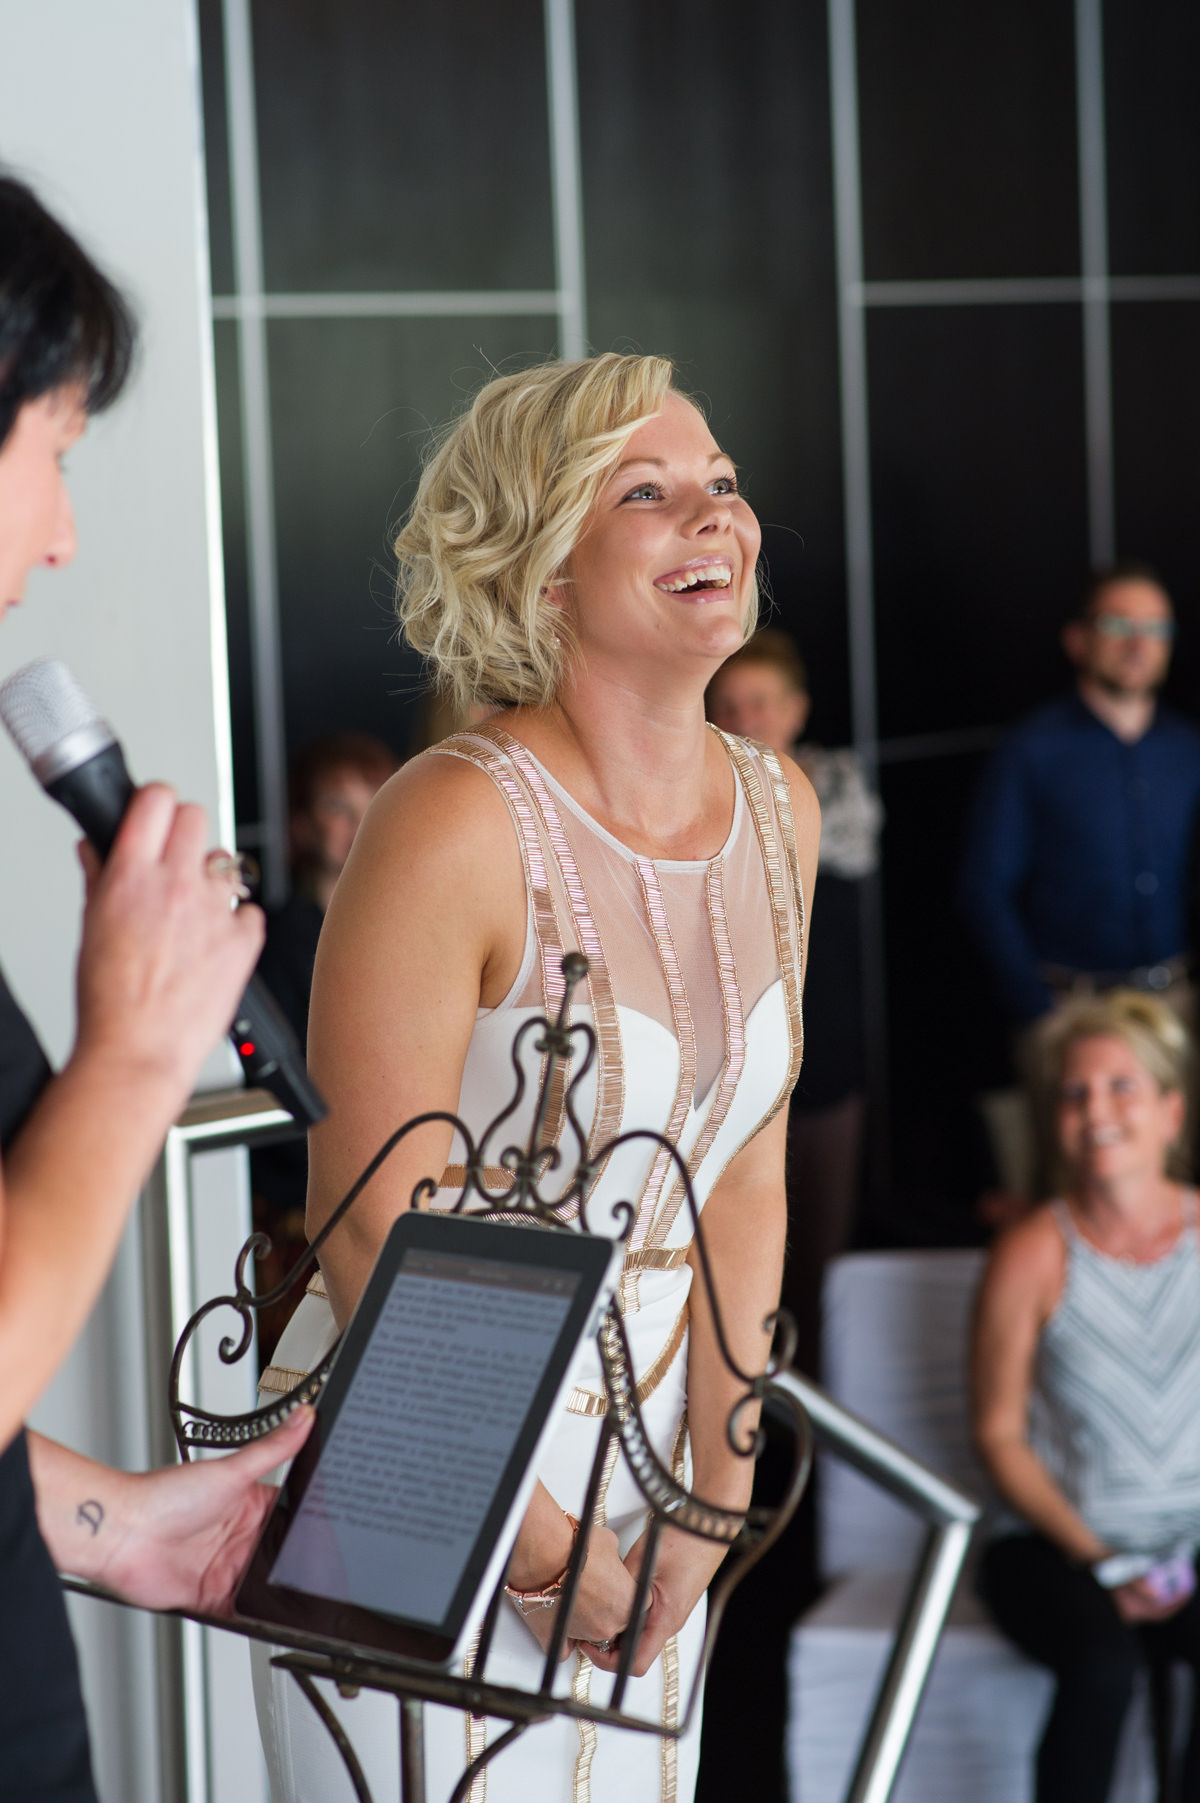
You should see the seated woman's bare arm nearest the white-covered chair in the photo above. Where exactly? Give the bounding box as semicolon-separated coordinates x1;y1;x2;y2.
971;1208;1108;1563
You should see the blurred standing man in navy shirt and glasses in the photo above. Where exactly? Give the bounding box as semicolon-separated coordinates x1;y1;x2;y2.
962;564;1200;1026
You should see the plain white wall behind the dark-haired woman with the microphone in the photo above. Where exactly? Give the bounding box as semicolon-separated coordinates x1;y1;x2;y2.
0;0;261;1803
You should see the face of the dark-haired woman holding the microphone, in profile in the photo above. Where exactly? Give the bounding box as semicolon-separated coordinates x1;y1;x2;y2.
0;388;86;617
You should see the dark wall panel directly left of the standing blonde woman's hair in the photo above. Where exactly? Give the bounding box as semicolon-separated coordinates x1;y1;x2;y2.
270;319;555;752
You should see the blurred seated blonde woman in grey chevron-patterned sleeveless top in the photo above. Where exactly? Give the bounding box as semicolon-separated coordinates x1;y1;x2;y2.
973;990;1200;1803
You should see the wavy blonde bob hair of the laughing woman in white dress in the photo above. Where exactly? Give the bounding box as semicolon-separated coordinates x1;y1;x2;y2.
395;352;757;710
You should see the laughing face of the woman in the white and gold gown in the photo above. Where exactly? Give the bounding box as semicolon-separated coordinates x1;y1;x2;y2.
557;393;760;680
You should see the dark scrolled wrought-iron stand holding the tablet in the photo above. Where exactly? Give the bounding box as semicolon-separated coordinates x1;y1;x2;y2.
161;952;811;1803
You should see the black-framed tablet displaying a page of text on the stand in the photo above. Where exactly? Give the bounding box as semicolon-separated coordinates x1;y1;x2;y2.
238;1213;618;1657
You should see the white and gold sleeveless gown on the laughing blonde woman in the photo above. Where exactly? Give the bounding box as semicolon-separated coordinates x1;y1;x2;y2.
254;725;804;1803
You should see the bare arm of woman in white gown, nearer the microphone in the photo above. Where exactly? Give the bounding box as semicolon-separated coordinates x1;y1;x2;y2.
308;757;526;1322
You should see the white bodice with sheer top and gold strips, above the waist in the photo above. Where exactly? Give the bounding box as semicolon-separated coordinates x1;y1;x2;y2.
427;727;804;1283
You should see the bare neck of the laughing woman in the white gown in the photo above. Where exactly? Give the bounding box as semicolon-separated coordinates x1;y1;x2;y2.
510;680;733;858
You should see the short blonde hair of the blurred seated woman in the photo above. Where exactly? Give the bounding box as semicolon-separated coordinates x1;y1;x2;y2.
1036;990;1193;1177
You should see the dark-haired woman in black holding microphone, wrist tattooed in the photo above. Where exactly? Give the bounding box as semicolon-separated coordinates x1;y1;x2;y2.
0;177;305;1803
